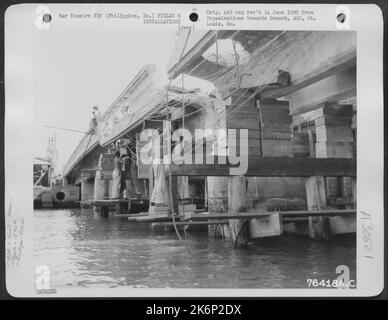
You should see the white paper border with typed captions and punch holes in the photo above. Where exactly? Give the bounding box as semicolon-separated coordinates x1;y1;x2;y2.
4;4;384;298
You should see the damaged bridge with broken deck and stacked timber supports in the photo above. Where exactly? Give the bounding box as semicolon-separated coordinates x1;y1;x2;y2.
64;30;357;244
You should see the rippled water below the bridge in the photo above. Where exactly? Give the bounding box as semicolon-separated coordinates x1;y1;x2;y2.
34;209;356;288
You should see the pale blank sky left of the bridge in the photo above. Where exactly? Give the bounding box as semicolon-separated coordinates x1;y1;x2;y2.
34;30;184;170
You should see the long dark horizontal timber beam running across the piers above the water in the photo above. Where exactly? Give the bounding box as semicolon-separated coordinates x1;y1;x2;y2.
171;157;357;177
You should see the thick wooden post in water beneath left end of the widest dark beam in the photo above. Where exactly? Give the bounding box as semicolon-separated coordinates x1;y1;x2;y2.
228;176;248;247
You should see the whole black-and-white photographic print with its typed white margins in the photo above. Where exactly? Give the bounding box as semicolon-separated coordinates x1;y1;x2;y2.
5;5;383;297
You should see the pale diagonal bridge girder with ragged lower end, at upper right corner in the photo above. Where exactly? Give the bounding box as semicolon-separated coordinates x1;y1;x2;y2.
215;31;356;99
